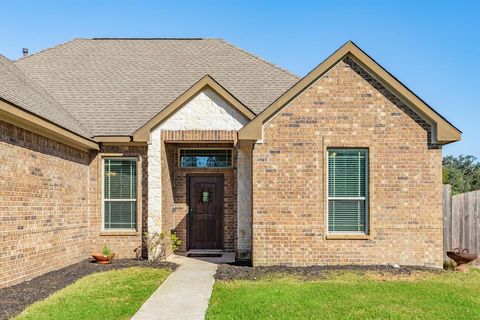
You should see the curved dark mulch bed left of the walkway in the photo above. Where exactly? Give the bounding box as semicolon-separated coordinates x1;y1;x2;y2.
0;259;177;320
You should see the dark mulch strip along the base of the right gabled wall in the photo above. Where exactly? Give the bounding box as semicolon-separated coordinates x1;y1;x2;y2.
215;264;445;281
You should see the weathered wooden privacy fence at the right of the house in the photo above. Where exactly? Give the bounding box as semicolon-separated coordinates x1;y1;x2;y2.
443;184;480;257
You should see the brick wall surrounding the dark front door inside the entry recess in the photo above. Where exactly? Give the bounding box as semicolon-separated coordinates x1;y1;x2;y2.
162;142;237;252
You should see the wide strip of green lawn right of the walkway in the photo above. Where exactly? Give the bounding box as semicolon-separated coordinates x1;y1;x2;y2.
207;270;480;320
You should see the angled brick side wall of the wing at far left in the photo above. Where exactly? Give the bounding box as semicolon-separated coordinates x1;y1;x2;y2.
0;121;91;287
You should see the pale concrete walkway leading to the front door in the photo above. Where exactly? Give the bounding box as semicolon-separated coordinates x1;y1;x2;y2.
132;256;217;320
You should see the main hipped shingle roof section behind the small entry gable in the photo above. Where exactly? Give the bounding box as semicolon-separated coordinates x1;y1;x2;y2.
15;39;299;136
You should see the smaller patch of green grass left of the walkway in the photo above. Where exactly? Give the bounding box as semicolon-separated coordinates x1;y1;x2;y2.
15;267;171;320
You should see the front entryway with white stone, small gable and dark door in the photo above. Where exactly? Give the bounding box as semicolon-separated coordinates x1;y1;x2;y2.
142;76;255;259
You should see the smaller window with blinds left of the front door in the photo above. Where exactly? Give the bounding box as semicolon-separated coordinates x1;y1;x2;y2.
103;158;137;230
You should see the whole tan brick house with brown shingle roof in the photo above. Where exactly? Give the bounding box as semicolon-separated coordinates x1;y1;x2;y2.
0;39;461;287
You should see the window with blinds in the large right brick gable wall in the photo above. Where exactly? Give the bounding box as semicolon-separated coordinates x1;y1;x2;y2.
328;149;368;234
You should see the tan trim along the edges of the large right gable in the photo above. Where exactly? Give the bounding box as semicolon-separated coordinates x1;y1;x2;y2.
239;41;461;144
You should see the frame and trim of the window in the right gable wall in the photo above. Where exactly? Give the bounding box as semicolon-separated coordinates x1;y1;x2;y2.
325;147;370;236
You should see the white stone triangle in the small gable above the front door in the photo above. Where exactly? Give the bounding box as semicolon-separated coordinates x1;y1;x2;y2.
160;89;248;131
